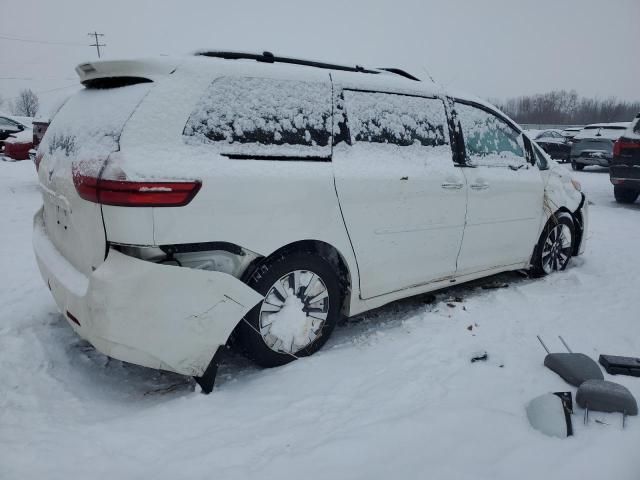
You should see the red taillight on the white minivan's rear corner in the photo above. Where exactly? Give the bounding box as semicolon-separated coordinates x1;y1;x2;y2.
73;164;202;207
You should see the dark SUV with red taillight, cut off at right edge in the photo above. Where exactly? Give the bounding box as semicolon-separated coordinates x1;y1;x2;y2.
609;113;640;203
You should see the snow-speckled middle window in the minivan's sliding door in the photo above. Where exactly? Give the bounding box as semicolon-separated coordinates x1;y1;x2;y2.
344;90;449;147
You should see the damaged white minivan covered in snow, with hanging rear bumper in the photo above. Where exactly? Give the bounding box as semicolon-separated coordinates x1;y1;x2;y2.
33;51;587;390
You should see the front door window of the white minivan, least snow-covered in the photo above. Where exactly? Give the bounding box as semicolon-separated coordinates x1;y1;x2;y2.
455;102;526;167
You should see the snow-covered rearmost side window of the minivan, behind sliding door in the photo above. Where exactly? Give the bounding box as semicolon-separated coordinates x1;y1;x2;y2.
183;77;331;152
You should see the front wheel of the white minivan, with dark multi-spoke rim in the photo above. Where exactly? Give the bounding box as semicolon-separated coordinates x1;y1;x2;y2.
532;212;575;275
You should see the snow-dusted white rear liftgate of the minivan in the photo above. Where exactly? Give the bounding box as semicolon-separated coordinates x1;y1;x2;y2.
38;83;152;274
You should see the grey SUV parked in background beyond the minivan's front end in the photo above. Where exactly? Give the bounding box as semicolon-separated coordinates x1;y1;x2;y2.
570;122;629;170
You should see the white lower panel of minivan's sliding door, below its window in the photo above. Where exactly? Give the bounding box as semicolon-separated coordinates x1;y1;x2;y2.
333;144;467;298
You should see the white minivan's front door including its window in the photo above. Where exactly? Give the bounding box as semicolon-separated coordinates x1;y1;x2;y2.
455;102;544;275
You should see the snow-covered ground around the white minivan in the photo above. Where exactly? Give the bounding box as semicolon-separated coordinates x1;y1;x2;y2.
0;161;640;480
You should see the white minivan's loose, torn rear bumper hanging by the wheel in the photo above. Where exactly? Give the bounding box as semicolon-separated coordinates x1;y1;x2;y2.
33;210;262;376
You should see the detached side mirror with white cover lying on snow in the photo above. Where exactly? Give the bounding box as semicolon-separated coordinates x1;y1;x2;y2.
527;392;573;438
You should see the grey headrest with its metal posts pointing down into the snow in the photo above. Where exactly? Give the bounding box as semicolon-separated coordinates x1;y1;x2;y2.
576;380;638;428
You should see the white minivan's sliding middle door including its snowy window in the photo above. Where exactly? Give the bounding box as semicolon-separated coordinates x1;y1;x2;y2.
333;90;467;298
